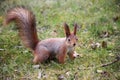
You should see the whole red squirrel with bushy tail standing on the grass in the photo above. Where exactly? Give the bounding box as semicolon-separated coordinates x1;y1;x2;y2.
5;7;78;63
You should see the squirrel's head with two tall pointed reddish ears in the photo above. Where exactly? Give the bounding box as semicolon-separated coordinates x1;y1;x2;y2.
64;23;78;47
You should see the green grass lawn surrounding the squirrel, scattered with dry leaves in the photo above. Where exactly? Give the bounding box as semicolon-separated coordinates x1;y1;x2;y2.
0;0;120;80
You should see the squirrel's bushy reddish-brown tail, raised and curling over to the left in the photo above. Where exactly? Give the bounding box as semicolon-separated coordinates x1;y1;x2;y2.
5;7;39;50
